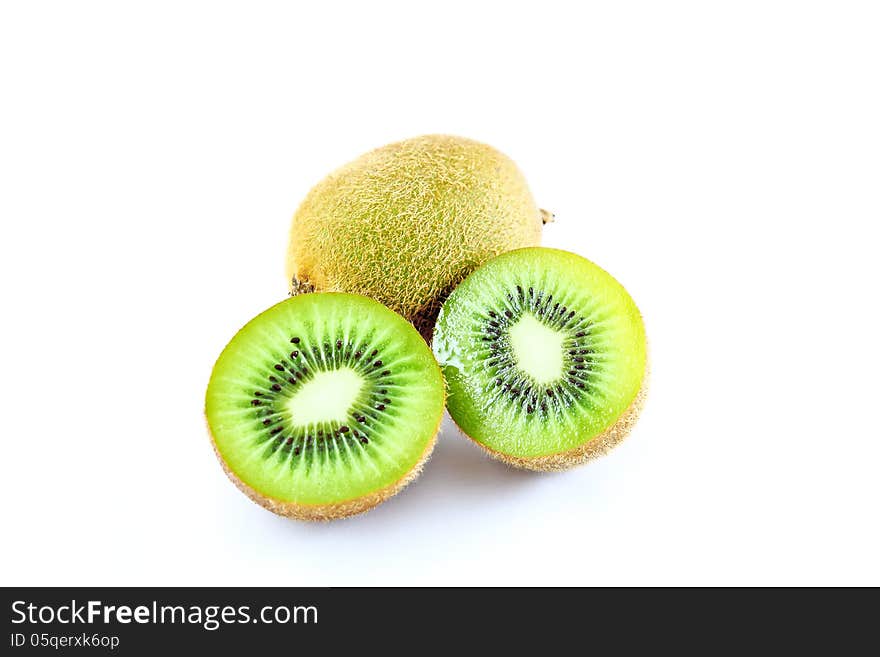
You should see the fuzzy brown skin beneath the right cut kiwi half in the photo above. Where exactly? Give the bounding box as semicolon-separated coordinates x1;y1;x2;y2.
458;368;648;472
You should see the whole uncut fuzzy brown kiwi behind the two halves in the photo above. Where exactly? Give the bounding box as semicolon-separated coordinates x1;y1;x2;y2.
287;135;552;339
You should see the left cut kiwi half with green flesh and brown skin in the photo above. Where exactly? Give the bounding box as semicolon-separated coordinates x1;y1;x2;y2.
206;293;444;520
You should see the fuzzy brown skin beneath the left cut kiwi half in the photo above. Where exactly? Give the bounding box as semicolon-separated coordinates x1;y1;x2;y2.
208;415;443;521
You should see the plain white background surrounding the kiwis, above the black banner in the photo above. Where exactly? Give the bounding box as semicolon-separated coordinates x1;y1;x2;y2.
0;0;880;585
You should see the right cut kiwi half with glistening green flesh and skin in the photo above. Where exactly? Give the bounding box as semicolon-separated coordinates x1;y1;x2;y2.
433;247;647;470
